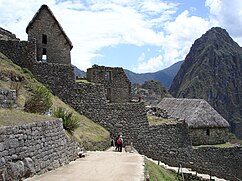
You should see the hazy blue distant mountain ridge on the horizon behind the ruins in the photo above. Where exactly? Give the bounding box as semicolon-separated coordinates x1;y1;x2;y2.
73;61;183;88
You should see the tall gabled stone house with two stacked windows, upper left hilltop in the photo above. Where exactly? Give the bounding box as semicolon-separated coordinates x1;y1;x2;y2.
26;5;73;64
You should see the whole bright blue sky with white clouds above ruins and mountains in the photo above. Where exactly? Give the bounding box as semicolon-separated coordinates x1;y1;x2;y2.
0;0;242;73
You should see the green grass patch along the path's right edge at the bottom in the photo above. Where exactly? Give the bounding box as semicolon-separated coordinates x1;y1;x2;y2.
145;159;182;181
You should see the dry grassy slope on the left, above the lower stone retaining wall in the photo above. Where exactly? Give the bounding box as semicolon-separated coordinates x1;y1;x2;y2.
0;53;110;150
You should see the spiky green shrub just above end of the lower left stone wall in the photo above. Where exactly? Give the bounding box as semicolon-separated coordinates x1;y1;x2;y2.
53;107;80;134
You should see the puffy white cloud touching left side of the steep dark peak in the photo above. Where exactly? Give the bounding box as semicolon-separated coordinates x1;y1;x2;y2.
134;10;210;72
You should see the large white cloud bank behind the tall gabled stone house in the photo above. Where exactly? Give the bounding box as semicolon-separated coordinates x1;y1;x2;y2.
0;0;176;70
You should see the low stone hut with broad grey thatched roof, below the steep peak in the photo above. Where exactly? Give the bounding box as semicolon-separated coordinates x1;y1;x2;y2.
157;98;229;145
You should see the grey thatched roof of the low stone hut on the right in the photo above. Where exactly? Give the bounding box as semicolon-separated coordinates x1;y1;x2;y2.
157;98;229;128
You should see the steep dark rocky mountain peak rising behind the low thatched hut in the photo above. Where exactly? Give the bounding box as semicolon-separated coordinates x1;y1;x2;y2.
169;27;242;136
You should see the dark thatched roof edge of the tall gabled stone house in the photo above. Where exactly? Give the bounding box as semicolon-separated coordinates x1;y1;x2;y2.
26;4;73;49
